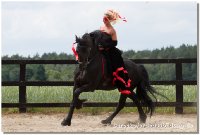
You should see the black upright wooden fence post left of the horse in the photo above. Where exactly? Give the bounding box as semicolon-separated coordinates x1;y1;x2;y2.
19;63;26;113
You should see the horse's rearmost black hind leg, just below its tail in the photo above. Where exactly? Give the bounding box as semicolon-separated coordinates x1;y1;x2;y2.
128;92;147;123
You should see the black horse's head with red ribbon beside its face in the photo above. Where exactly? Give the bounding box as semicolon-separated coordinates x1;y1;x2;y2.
76;33;93;63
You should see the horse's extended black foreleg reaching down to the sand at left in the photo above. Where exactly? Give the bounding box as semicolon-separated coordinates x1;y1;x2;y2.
61;85;89;126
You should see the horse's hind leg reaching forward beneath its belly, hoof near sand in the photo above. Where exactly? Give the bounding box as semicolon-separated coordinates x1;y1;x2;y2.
101;94;127;124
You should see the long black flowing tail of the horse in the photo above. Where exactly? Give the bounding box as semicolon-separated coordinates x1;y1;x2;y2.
136;65;157;116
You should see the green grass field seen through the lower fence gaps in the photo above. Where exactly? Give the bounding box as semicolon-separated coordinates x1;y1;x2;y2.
1;86;197;115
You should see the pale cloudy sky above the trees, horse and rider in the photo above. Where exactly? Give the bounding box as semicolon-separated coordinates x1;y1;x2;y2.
1;1;197;56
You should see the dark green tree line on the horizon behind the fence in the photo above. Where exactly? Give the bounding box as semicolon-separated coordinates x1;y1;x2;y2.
2;44;197;81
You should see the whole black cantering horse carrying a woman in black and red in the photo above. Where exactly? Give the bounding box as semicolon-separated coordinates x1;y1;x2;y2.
61;31;158;126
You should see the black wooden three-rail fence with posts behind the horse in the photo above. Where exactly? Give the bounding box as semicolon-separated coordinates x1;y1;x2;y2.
2;59;197;114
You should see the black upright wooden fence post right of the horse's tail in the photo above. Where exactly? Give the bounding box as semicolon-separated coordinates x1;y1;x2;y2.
175;61;183;114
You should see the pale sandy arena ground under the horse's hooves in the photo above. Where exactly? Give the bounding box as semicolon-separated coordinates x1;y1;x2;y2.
2;113;197;133
